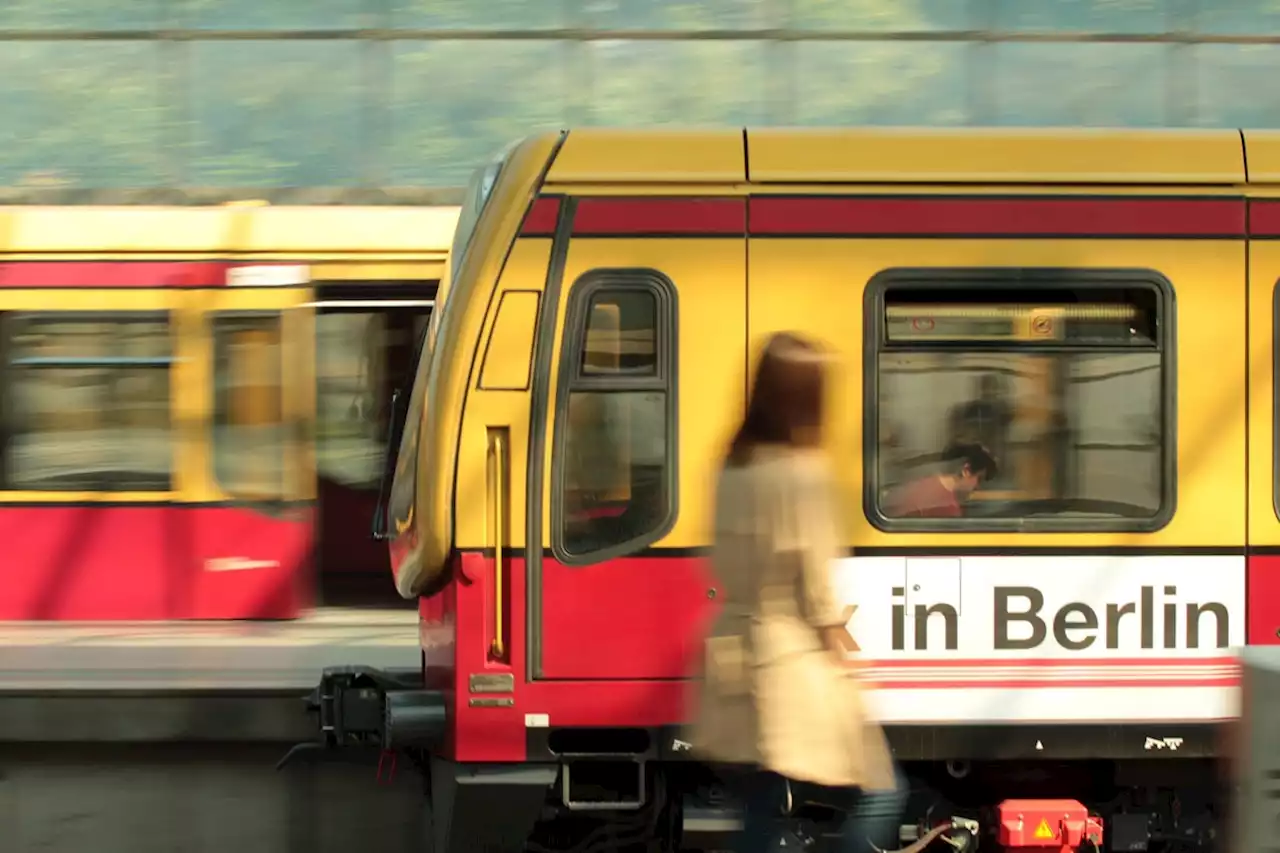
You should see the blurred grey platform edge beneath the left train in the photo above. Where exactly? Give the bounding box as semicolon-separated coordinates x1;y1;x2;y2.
0;607;420;743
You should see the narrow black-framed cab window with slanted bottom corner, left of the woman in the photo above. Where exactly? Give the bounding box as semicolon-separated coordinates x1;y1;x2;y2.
552;270;677;564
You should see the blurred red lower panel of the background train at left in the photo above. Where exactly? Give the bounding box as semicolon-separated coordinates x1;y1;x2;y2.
0;506;315;621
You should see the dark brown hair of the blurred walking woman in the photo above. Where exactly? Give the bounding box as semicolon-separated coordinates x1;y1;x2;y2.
727;332;827;466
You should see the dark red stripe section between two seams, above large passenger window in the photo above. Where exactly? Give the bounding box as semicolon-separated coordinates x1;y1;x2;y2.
749;196;1245;237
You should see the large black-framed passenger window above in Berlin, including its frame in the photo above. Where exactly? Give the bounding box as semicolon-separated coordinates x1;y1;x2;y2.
865;270;1175;530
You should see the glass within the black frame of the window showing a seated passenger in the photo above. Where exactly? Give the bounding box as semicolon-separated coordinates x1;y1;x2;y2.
877;289;1165;521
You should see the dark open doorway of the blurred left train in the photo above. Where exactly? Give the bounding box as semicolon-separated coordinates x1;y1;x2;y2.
314;279;436;603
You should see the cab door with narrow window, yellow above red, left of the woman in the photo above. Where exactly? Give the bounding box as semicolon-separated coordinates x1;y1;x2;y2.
529;196;746;679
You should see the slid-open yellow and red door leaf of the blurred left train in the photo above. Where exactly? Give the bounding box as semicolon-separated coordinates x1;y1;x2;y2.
189;265;315;619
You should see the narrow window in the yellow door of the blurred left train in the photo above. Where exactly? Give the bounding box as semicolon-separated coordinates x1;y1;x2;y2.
214;314;287;501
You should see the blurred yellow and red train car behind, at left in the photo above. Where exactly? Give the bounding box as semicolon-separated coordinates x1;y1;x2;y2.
0;204;458;620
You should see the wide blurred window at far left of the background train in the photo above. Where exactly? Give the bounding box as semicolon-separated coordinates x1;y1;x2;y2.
3;314;173;492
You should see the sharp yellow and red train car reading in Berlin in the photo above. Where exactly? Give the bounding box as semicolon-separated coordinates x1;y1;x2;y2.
299;129;1280;850
